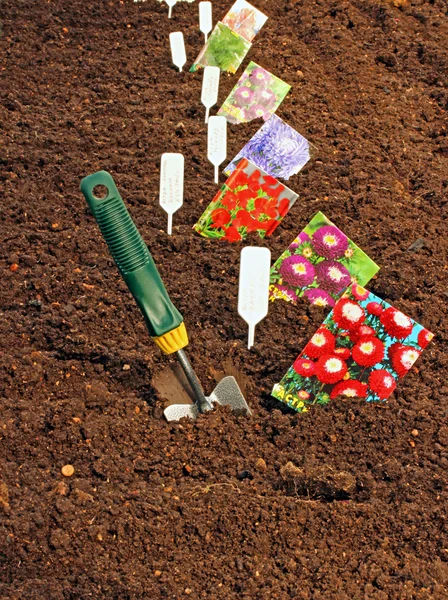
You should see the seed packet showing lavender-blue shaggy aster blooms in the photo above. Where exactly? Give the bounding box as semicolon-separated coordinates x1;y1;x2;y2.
224;115;311;179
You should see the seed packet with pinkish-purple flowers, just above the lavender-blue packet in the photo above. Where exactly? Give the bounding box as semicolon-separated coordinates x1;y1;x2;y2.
218;62;291;123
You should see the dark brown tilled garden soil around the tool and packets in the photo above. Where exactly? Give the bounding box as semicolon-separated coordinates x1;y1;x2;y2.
0;0;448;600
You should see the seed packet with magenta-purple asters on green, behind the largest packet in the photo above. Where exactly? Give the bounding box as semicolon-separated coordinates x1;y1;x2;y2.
269;212;379;307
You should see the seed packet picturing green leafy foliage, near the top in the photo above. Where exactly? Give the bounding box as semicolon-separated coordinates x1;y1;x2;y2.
190;22;252;73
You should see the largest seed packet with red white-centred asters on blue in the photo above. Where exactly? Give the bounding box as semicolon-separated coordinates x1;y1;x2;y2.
272;284;434;412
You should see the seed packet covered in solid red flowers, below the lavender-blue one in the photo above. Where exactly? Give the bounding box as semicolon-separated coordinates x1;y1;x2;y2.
193;158;298;242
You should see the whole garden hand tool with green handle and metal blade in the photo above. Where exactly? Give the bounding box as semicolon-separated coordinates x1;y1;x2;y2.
81;171;251;421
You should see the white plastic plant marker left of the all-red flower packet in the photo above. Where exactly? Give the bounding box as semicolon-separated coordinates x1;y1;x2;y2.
159;152;184;235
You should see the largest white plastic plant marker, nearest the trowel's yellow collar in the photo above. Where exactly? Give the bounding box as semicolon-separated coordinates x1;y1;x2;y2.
238;246;271;348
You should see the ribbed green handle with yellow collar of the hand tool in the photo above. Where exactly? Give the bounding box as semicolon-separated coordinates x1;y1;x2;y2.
81;171;188;354
